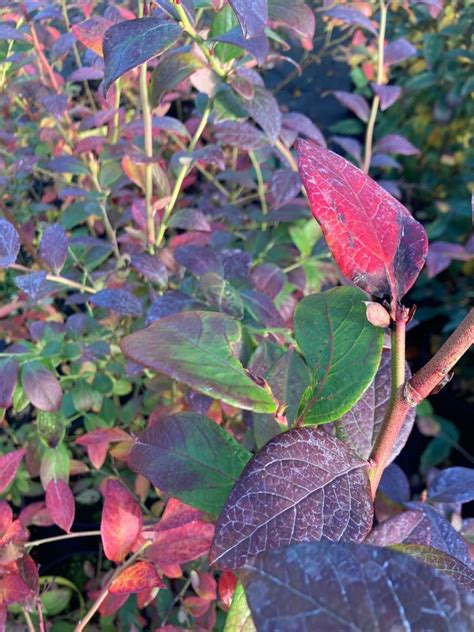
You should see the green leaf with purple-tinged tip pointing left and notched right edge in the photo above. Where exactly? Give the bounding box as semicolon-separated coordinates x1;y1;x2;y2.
121;311;276;413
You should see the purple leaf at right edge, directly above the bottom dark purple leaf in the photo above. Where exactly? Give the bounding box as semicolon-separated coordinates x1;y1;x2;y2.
365;503;469;564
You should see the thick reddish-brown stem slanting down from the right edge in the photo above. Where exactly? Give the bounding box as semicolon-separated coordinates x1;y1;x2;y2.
369;310;474;498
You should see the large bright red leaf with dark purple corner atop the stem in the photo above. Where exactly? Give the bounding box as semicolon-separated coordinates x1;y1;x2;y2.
298;141;428;305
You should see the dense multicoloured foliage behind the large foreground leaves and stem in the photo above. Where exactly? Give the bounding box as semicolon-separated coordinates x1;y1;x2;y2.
0;0;474;632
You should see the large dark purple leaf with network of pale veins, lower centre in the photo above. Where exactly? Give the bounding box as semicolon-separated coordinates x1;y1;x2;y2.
209;428;373;569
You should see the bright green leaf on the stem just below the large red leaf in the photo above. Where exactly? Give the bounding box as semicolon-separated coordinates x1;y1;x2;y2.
294;287;383;424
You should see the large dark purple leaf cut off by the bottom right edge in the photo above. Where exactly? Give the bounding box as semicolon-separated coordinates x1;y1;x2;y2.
242;542;473;632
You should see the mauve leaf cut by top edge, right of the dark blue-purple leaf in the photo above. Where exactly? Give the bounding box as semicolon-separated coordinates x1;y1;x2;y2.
268;0;316;50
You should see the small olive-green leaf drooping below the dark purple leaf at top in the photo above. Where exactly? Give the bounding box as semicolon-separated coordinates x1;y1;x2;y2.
150;51;204;107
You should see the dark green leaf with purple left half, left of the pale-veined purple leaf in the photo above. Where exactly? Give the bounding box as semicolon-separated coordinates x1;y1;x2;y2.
128;413;252;516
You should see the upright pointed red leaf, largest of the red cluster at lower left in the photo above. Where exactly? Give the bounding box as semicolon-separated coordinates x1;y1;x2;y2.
100;479;143;563
